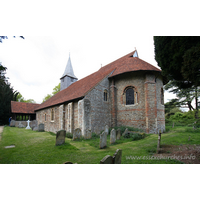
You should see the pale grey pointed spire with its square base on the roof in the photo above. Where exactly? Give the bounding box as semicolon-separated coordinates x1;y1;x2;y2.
60;56;78;90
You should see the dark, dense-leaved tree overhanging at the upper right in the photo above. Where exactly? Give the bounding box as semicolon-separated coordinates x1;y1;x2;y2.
154;36;200;119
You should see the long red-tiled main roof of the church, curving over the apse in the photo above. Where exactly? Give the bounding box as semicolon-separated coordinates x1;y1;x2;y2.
35;51;161;111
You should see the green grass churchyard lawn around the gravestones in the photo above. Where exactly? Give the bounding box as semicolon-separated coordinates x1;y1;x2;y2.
0;127;200;164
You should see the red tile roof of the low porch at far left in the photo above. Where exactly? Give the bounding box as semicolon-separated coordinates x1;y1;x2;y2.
11;101;40;114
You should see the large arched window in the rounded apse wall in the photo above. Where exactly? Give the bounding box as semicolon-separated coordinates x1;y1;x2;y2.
123;86;138;105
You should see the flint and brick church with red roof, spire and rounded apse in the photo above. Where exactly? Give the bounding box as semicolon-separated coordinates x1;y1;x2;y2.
35;50;165;136
